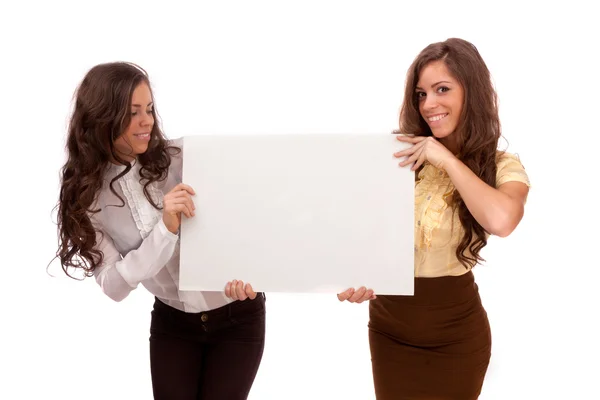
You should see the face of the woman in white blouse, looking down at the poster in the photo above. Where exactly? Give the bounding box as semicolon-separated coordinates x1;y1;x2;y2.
115;82;154;161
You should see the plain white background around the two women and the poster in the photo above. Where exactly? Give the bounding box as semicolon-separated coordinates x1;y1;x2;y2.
0;0;600;400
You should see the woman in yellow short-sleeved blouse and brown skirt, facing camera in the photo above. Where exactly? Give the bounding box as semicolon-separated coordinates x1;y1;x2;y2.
338;39;529;400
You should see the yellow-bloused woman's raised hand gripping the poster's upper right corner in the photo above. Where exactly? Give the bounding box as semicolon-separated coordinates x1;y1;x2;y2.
394;134;456;171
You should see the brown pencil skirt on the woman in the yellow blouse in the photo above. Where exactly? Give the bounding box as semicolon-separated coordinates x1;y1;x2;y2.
369;272;492;400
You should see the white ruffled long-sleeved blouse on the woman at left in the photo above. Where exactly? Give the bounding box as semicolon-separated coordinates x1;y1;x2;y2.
92;139;231;313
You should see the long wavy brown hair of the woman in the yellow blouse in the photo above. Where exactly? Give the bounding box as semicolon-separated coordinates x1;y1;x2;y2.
400;38;501;268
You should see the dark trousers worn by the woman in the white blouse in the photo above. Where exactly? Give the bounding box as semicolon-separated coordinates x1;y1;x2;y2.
150;293;265;400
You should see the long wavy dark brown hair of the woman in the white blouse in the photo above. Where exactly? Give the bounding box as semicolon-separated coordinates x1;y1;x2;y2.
56;62;181;279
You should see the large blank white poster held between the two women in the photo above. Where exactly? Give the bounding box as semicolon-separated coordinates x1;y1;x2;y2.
180;133;414;295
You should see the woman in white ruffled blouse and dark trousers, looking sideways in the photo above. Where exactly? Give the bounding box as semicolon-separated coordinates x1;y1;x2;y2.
57;63;265;400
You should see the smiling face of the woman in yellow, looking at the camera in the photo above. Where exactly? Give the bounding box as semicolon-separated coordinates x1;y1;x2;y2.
415;60;464;147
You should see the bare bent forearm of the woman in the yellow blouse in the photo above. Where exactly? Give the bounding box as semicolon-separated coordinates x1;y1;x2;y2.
444;158;523;237
